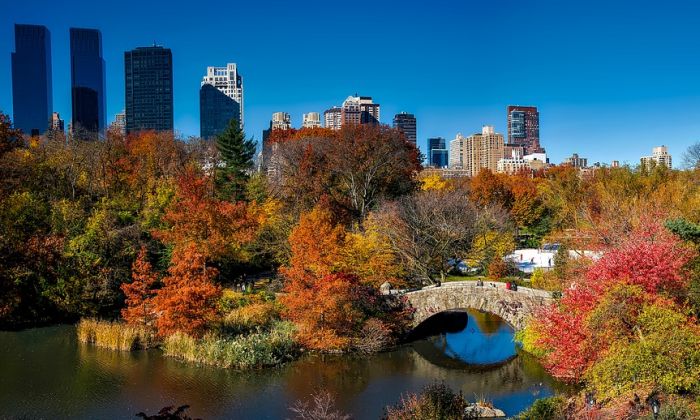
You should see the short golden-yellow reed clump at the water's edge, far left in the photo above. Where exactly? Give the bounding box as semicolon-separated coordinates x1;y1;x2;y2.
77;319;158;351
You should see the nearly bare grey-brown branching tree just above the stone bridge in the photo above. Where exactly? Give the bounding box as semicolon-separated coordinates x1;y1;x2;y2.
376;190;492;283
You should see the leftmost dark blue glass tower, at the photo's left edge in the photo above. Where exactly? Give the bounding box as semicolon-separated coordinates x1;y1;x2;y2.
12;25;53;136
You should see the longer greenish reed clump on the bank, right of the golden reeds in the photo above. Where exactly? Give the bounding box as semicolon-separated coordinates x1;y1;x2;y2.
163;322;297;369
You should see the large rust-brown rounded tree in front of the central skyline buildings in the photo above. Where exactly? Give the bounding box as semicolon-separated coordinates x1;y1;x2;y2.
270;125;420;223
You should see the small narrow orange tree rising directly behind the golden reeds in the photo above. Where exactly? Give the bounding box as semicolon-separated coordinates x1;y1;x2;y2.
121;246;158;326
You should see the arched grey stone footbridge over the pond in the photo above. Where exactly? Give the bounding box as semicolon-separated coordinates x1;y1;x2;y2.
391;281;554;330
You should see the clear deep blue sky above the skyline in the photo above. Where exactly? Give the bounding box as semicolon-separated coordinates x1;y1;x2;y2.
0;0;700;164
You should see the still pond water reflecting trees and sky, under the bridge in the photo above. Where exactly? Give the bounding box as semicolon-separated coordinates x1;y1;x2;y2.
0;311;561;419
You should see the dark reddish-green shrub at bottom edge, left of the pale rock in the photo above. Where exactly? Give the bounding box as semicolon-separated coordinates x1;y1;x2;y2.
385;383;469;420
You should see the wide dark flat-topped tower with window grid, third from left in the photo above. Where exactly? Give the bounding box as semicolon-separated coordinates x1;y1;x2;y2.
124;45;173;133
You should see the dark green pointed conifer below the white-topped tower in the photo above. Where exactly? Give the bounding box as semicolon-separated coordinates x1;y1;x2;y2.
216;119;256;200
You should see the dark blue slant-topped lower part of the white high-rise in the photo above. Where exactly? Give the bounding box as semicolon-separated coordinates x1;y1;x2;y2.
199;84;241;139
